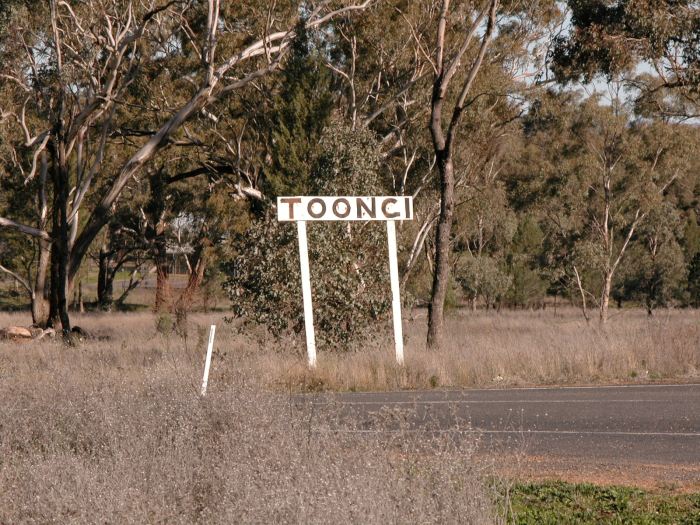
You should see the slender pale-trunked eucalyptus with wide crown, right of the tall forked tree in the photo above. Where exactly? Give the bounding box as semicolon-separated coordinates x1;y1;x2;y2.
512;93;694;323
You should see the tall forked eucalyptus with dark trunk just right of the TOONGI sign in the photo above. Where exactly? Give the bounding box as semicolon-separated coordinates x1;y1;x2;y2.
408;0;558;347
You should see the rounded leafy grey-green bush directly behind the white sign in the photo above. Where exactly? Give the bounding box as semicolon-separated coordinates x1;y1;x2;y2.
224;123;390;350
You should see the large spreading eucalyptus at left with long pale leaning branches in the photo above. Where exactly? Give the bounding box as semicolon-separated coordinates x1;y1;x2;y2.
0;0;370;333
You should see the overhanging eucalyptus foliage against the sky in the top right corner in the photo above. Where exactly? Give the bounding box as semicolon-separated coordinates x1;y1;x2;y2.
551;0;700;119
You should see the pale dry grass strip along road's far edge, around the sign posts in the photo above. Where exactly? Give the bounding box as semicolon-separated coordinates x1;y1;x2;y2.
247;310;700;390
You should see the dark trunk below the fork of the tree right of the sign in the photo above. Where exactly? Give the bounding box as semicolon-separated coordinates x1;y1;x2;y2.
427;155;454;348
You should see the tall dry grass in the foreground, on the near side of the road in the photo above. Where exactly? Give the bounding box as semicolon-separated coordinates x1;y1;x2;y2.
0;316;496;523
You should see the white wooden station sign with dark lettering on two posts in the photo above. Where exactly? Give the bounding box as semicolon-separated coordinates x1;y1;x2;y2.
277;197;413;368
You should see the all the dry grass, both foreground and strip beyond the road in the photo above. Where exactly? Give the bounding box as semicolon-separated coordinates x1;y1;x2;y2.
0;310;700;523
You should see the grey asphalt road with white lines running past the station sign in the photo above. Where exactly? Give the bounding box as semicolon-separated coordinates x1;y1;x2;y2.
304;385;700;466
